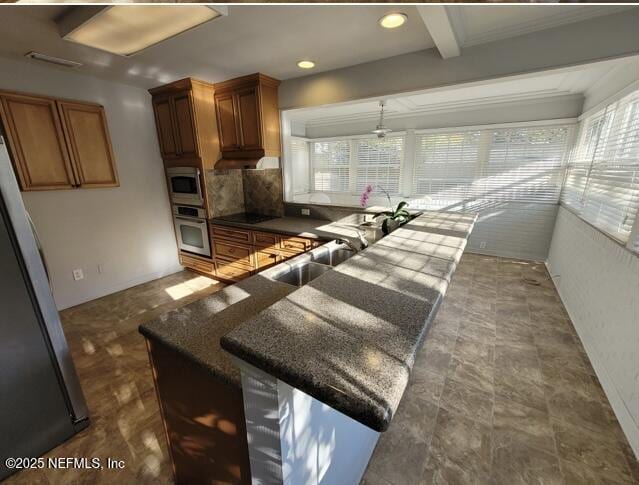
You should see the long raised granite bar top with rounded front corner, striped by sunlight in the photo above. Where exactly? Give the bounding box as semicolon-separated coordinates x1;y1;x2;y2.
221;212;476;431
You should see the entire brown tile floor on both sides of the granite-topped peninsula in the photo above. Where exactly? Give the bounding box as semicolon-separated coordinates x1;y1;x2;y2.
7;254;639;485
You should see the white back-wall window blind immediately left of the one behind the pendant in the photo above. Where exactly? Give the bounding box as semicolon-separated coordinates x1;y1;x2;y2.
311;140;351;192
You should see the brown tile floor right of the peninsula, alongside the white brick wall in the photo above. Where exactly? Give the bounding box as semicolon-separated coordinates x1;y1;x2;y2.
363;254;639;485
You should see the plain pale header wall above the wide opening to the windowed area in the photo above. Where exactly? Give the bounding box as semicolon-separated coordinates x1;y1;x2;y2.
279;8;639;109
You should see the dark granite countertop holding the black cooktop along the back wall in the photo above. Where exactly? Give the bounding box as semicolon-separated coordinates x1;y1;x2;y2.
209;216;380;241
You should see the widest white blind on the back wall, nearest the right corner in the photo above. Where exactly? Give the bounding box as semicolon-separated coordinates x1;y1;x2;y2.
413;126;569;208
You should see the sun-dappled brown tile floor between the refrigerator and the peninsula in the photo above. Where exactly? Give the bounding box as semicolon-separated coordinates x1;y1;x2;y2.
3;271;224;485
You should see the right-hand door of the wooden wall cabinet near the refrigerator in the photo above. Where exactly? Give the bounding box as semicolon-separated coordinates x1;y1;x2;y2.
58;101;120;187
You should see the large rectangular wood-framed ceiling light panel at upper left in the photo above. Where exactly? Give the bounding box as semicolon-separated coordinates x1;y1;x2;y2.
58;5;227;56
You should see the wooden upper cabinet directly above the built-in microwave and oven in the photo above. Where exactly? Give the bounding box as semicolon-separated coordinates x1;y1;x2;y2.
149;78;219;168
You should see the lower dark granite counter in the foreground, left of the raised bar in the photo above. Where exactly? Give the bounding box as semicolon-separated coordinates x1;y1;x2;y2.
139;275;295;387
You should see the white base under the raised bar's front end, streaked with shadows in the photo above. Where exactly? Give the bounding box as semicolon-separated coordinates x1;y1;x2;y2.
234;359;379;485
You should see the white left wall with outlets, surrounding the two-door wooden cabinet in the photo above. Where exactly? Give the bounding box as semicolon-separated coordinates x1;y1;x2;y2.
0;58;181;309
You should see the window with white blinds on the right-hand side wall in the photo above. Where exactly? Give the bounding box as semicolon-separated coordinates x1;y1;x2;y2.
561;91;639;243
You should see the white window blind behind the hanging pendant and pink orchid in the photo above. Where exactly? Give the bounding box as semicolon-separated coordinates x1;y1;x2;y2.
356;136;404;194
